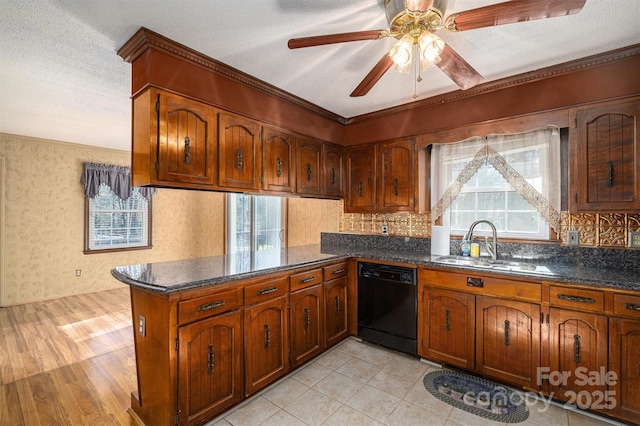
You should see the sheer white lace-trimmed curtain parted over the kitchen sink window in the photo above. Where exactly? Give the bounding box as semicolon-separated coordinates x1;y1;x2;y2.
431;126;561;232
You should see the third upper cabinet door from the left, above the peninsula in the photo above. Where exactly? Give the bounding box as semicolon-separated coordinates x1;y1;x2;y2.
262;127;295;192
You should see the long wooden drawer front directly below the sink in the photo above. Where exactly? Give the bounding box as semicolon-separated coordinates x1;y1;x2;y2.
419;270;542;303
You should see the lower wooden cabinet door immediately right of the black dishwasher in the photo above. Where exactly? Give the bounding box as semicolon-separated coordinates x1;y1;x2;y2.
418;286;475;370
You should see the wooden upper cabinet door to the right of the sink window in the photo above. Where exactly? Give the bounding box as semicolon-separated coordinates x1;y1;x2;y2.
572;101;640;210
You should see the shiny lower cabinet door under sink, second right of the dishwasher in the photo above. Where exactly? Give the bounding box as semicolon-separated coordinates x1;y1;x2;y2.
476;296;540;389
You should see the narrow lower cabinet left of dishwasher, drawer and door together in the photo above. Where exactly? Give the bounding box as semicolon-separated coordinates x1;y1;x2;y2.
323;262;349;348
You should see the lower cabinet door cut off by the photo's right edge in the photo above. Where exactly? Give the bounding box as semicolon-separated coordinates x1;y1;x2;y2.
603;318;640;422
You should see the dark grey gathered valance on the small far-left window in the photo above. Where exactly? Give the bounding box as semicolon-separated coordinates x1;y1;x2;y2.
81;163;156;200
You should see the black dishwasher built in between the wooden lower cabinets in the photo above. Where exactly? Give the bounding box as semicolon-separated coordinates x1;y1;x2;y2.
358;262;418;356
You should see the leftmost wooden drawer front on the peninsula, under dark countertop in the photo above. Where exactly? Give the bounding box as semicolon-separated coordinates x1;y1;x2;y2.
178;289;242;325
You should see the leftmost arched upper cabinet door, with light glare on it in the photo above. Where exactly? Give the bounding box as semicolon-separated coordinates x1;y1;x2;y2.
156;93;216;185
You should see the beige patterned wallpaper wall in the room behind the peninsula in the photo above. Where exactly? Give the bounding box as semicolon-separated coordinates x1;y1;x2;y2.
0;133;338;306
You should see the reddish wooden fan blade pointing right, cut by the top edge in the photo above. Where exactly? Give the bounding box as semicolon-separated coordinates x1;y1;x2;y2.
447;0;586;31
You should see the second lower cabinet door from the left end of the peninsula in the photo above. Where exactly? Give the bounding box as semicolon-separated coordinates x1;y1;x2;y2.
244;295;289;396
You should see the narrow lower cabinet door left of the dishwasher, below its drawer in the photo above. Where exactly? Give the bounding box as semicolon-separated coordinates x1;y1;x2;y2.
324;277;349;348
